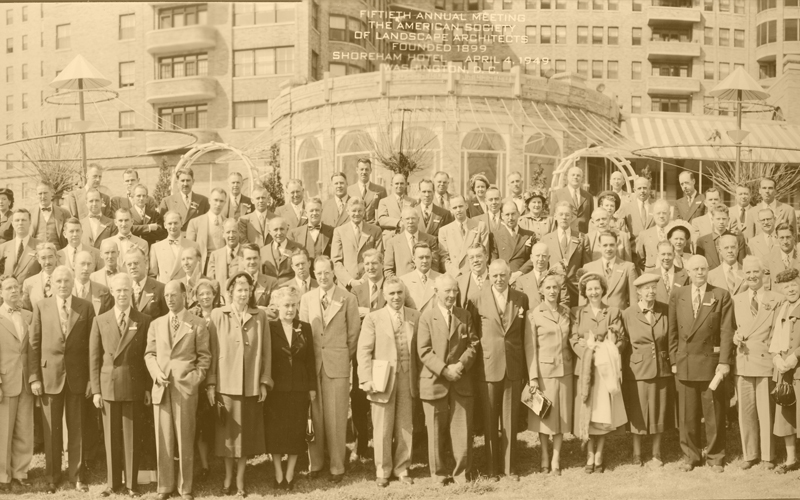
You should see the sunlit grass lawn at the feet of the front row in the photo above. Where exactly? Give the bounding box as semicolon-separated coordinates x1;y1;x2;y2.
4;423;800;500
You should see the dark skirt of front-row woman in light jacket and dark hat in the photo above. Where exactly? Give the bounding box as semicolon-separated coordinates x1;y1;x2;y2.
215;394;264;458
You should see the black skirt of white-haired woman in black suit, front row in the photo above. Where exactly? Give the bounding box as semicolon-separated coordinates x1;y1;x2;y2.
264;391;309;455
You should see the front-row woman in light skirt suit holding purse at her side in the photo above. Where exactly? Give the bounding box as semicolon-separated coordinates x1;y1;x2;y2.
525;268;574;476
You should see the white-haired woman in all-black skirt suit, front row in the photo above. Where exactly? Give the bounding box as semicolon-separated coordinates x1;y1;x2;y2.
265;286;317;490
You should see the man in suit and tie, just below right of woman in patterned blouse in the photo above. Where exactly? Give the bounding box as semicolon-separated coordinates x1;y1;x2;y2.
542;201;591;307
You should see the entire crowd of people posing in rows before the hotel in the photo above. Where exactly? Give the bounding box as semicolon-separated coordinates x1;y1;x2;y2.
0;159;800;500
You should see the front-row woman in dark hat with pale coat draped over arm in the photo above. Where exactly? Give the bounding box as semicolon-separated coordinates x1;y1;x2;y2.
569;273;628;474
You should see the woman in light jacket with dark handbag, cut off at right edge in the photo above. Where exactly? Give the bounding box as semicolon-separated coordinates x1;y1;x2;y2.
769;269;800;474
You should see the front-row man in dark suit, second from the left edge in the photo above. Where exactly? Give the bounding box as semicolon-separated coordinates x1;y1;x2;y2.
28;266;95;493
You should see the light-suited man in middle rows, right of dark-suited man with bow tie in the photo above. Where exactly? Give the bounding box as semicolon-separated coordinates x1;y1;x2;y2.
331;198;383;288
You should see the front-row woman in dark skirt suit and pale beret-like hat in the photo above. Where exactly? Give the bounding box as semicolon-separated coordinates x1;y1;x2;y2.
622;274;676;467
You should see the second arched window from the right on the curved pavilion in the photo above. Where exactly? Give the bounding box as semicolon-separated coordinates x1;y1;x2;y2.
461;128;506;193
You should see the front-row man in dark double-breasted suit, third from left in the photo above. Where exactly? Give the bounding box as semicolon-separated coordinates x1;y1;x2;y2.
89;274;152;497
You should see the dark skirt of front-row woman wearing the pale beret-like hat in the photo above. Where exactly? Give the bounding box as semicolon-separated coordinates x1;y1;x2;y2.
622;377;677;435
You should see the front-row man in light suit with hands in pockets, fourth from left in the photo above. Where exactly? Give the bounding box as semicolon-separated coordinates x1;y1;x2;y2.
144;280;211;500
